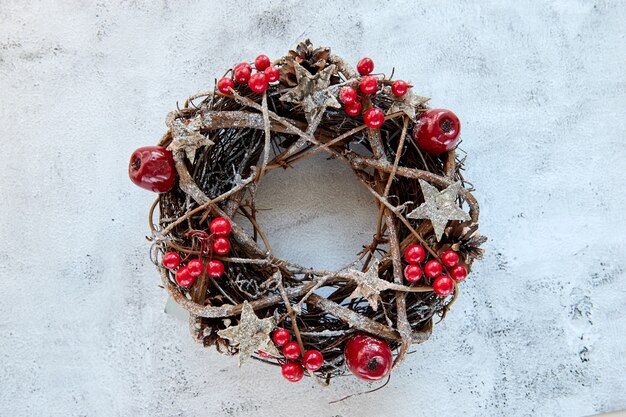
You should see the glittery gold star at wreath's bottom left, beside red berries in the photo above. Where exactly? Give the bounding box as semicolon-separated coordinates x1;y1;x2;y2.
217;301;280;366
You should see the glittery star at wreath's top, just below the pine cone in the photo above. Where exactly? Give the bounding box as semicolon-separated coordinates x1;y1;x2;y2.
280;64;341;123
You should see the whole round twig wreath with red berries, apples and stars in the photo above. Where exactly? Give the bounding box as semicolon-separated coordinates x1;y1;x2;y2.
129;41;485;385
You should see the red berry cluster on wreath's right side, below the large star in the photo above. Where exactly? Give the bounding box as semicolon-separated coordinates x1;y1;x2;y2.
404;244;467;297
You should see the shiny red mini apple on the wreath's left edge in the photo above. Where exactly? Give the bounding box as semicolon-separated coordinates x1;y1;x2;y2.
128;146;176;193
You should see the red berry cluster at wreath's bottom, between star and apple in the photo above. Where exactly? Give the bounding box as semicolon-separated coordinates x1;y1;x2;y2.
268;329;324;382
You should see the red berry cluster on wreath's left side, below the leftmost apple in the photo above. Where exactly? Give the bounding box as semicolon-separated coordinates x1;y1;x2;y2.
162;217;232;288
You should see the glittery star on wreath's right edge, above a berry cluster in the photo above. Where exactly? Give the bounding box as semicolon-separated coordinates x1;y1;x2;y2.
406;180;470;241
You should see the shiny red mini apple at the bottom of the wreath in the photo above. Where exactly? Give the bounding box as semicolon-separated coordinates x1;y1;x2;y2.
343;334;393;381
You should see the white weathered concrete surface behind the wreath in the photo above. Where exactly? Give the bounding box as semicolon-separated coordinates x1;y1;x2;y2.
0;0;626;417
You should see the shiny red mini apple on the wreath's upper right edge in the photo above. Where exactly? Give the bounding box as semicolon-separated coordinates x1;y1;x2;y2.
413;109;461;154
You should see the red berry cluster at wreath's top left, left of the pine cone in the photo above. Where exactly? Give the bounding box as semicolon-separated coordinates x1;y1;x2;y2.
217;55;280;94
